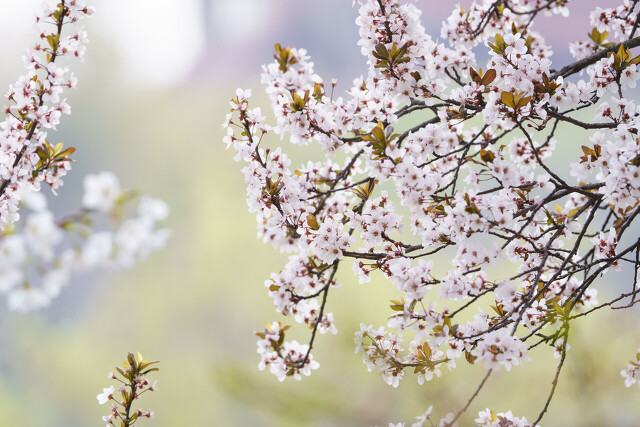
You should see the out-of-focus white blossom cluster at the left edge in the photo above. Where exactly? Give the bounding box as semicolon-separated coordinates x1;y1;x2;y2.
0;172;169;312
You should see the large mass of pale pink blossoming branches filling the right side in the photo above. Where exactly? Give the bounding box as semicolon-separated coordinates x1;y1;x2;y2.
223;0;640;426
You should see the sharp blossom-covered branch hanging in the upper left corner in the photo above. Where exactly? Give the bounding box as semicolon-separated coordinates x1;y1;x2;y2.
0;0;94;228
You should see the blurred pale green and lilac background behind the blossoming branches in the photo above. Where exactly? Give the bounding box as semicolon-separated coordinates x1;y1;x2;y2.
0;0;640;427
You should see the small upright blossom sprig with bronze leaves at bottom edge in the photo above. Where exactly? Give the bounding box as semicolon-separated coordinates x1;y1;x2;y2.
96;352;159;427
